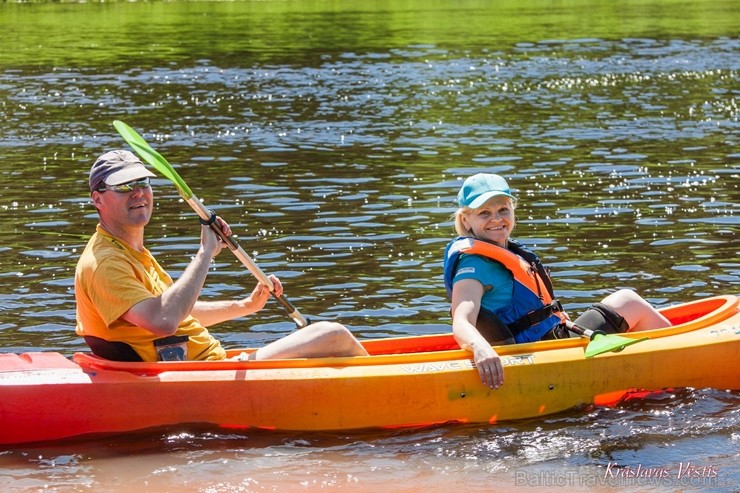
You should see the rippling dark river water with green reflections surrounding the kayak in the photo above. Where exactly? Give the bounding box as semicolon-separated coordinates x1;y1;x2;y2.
0;0;740;493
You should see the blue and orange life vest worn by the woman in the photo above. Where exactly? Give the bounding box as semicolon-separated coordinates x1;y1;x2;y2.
444;237;564;342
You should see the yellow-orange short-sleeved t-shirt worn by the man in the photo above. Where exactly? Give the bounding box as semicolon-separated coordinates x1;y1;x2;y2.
75;225;226;361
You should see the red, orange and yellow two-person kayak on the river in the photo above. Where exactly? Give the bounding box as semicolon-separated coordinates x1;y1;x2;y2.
0;295;740;445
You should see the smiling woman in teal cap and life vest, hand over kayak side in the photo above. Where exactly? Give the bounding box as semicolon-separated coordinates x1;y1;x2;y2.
445;173;670;388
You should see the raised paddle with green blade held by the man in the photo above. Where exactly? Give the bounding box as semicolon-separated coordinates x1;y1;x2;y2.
113;120;308;328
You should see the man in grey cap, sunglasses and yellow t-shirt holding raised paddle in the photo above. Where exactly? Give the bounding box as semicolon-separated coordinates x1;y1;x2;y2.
75;150;367;361
